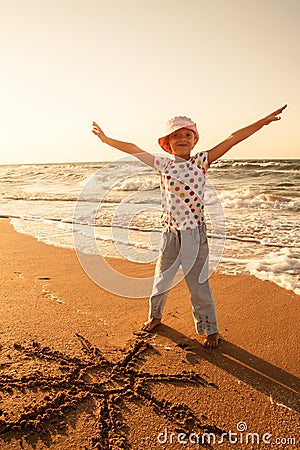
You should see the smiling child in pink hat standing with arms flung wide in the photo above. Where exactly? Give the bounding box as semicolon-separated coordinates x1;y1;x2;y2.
93;105;287;348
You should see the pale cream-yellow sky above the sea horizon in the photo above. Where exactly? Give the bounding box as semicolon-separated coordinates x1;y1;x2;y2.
0;0;300;164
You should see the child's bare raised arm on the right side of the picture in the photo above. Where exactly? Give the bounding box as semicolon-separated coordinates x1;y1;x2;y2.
208;105;287;164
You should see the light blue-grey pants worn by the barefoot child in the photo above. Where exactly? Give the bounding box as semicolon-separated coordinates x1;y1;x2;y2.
149;225;218;335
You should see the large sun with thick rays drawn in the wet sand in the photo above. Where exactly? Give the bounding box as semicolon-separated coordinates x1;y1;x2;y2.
0;332;222;450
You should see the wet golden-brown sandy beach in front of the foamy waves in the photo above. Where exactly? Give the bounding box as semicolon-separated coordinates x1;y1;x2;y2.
0;220;300;450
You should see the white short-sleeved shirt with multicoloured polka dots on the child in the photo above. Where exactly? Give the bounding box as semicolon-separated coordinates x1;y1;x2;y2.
154;152;208;230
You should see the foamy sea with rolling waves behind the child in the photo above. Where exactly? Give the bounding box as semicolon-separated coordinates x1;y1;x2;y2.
0;157;300;295
